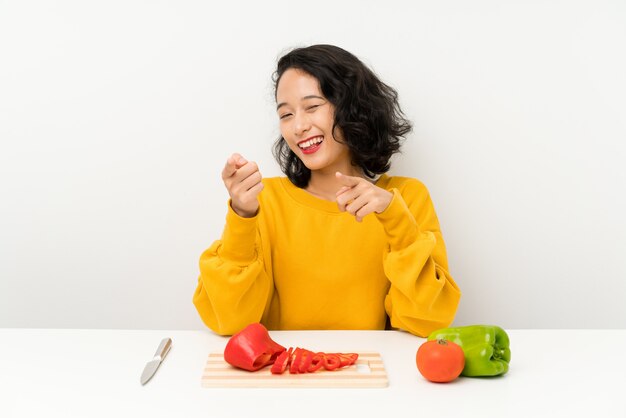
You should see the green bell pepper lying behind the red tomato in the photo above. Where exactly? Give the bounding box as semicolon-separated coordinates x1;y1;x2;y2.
428;325;511;377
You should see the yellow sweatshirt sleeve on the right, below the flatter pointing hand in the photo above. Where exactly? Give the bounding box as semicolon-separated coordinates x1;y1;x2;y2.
376;181;461;337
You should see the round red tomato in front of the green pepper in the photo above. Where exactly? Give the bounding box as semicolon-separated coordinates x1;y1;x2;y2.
415;340;465;383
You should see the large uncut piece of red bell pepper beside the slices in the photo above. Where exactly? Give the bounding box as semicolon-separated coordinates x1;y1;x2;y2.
224;322;285;371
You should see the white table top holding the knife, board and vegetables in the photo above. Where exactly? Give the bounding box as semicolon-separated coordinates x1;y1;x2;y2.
0;329;626;418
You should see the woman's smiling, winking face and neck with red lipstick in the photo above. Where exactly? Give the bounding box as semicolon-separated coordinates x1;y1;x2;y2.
276;68;351;175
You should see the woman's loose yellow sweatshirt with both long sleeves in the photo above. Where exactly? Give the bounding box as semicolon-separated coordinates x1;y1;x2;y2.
193;175;461;336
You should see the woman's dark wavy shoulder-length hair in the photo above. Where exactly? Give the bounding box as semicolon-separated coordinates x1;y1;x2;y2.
273;45;411;187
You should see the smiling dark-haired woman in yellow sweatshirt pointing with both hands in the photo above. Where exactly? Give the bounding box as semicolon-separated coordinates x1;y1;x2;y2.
193;45;460;336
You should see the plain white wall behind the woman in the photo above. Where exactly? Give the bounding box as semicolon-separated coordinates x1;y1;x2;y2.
0;0;626;329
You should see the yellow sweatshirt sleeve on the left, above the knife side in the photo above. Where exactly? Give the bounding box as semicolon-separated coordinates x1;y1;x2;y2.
193;202;273;335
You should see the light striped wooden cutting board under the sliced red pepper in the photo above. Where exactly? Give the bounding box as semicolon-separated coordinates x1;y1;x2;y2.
202;352;389;388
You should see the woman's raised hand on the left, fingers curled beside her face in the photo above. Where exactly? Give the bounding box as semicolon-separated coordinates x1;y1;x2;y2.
222;154;263;218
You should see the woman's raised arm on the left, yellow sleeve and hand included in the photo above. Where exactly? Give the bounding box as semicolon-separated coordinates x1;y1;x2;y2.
193;154;274;335
